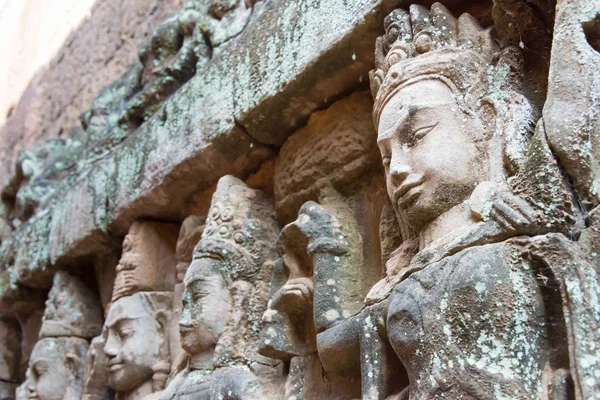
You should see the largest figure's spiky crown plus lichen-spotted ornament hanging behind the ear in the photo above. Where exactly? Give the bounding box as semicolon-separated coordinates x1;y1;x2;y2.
370;3;534;177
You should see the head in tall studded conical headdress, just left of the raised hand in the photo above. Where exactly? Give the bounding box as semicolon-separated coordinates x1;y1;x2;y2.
179;176;277;364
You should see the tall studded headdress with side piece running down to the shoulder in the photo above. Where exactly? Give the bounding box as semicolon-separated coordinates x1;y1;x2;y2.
188;175;278;366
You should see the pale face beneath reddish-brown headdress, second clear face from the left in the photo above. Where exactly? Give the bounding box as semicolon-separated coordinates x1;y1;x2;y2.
104;293;162;392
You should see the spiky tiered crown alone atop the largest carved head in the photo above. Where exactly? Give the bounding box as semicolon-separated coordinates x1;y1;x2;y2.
370;3;522;123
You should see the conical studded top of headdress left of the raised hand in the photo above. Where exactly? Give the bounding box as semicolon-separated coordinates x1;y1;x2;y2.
194;175;278;283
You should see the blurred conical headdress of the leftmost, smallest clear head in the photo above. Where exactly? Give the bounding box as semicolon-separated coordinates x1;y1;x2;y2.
40;271;102;339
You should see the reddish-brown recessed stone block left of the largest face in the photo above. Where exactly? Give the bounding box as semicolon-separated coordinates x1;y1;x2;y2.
274;92;380;221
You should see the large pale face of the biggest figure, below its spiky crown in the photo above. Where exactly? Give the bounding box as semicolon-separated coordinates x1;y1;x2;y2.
377;79;489;231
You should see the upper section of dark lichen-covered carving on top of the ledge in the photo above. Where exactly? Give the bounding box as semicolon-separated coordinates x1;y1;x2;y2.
81;0;254;153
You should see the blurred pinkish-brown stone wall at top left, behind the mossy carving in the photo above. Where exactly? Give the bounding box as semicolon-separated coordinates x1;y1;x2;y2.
0;0;181;181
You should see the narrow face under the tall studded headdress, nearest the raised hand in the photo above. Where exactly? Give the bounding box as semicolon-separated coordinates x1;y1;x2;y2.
179;257;231;355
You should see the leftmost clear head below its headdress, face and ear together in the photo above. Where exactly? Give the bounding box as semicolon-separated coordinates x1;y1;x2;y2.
27;337;88;400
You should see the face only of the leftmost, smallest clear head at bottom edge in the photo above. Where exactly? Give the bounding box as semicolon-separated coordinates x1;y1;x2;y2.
27;338;72;400
